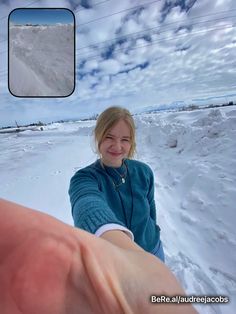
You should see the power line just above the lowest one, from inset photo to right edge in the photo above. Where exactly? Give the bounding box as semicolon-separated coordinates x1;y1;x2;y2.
76;9;236;51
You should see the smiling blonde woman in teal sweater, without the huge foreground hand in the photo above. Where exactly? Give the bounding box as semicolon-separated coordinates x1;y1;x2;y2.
69;107;164;262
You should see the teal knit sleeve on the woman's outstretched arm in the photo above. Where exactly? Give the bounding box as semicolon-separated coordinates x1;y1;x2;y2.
69;169;124;234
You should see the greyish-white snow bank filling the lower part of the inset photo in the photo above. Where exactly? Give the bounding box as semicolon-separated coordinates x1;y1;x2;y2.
9;24;74;97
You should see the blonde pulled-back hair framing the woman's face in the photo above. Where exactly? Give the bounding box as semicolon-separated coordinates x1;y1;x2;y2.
94;107;136;158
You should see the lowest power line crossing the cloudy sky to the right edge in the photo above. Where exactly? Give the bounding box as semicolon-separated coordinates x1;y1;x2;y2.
76;25;236;61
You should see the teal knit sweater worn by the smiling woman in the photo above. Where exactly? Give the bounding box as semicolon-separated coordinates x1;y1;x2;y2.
69;159;160;252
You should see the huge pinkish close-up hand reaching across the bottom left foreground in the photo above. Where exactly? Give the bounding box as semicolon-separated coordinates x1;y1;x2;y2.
0;199;196;314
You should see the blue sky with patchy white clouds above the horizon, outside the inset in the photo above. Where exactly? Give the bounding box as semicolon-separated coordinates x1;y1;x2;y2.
0;0;236;126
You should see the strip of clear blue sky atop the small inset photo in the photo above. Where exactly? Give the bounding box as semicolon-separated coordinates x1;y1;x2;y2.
10;8;74;25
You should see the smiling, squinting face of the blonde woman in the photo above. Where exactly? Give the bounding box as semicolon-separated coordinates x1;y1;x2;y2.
99;120;131;167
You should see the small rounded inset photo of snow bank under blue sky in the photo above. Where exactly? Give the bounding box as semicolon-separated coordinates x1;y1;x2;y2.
8;8;75;97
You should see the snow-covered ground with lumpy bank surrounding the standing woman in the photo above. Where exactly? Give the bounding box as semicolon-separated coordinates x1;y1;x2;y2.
0;106;236;314
